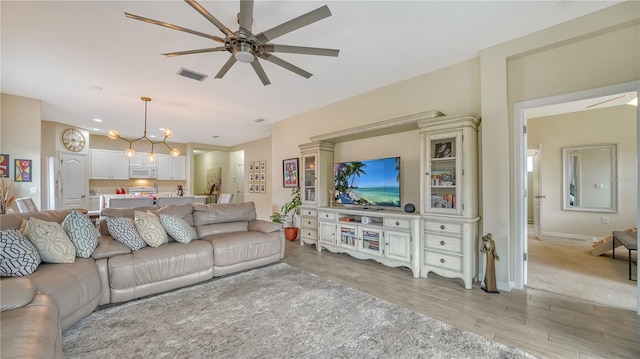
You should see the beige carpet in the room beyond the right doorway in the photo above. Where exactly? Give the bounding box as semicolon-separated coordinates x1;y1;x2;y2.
527;238;638;311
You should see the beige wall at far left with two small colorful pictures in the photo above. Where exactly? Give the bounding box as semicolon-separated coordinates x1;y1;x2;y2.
0;94;42;208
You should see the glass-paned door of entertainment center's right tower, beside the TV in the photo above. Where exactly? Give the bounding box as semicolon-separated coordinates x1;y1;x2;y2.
425;133;461;213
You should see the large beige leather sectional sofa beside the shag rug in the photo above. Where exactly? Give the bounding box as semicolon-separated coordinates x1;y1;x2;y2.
0;202;284;358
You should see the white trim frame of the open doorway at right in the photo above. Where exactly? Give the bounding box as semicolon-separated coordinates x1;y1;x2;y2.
513;81;640;309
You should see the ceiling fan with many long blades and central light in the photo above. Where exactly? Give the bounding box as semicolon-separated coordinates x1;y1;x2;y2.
124;0;340;86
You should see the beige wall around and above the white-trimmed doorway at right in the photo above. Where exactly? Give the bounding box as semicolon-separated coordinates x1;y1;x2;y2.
480;1;640;288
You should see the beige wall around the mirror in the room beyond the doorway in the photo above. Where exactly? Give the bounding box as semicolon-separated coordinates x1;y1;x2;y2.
527;105;638;239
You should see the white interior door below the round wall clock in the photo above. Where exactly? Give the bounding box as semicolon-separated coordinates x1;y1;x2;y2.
59;153;87;209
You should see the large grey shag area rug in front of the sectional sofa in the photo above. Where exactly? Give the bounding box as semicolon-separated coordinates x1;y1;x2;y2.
63;263;533;359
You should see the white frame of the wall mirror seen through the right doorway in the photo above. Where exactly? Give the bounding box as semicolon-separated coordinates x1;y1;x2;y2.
562;143;618;213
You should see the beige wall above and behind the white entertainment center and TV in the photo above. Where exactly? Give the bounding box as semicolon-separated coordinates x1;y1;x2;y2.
272;58;480;214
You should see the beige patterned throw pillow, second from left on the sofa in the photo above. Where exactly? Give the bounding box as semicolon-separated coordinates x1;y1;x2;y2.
24;217;76;263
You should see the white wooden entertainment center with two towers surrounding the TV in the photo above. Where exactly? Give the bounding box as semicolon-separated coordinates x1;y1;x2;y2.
299;111;480;289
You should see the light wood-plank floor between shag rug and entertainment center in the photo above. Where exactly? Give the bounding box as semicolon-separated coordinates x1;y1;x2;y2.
283;241;640;359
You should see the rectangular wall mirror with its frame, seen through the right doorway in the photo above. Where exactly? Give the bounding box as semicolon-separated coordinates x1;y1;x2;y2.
562;144;618;212
